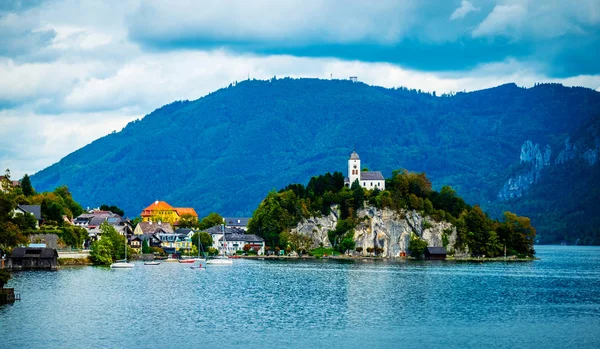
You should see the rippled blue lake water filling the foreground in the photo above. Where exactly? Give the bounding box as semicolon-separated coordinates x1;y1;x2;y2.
0;246;600;348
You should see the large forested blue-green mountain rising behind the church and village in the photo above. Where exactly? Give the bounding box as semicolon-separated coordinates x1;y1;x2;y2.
31;78;600;243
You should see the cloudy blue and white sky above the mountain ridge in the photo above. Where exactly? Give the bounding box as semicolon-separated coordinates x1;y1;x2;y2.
0;0;600;179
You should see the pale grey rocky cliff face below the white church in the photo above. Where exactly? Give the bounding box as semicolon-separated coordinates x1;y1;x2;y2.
292;206;466;257
